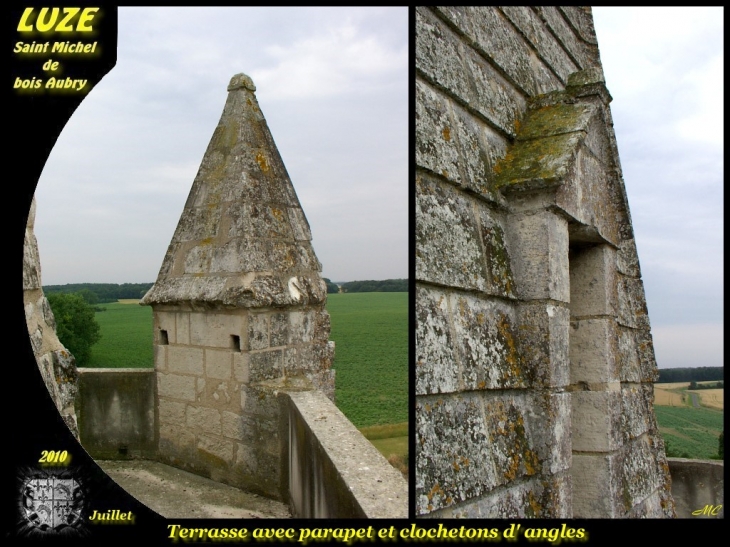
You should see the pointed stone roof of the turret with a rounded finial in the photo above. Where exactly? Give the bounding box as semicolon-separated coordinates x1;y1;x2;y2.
142;74;326;308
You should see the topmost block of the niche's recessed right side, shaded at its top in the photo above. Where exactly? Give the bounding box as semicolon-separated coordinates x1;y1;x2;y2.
570;245;617;318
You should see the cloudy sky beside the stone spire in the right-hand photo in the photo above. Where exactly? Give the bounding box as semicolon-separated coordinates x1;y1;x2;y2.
593;7;724;368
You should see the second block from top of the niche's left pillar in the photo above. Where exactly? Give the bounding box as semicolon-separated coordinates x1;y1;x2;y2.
517;302;570;387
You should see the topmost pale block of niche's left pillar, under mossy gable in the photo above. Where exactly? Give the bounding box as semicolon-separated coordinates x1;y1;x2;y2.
507;211;570;302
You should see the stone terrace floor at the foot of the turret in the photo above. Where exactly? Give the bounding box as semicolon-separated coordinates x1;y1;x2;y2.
96;460;291;518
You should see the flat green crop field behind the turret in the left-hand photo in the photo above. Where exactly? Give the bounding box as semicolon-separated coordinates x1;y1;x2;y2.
90;293;408;434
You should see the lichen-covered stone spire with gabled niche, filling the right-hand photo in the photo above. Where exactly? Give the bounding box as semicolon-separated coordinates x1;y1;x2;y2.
415;6;674;518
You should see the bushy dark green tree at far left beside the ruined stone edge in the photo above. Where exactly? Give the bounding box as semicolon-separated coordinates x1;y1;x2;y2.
47;293;101;367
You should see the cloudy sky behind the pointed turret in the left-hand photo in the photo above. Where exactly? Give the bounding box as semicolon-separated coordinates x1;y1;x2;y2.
35;8;408;284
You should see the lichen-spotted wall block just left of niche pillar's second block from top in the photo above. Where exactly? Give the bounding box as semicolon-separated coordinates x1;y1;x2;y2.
450;293;533;390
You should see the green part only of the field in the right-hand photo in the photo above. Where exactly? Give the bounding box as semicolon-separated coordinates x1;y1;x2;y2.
654;405;723;460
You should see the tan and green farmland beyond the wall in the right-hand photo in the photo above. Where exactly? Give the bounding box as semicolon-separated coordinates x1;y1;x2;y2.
654;382;724;459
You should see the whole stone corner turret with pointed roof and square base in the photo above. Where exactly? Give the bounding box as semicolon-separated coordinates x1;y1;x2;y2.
142;74;334;497
